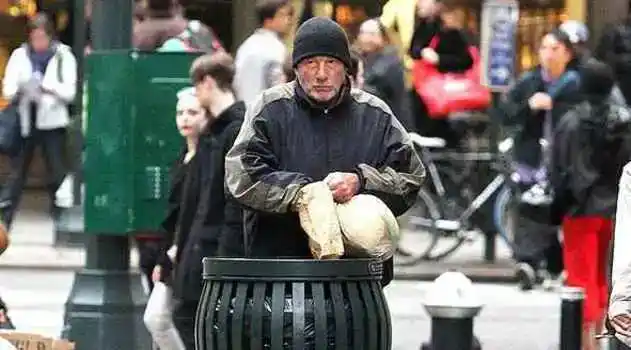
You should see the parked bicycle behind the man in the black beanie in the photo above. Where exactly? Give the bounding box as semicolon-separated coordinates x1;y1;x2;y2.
397;133;512;265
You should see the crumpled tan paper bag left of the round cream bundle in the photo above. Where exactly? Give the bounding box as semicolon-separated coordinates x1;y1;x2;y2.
294;181;344;259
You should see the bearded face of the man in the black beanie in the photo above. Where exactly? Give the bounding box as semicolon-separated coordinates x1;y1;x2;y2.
297;56;346;103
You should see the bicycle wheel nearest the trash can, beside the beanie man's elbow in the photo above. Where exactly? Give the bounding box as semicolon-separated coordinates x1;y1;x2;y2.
395;189;442;266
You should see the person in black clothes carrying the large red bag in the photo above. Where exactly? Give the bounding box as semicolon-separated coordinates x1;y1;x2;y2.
410;4;473;148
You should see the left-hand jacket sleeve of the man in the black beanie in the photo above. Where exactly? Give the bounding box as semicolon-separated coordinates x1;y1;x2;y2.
226;94;313;213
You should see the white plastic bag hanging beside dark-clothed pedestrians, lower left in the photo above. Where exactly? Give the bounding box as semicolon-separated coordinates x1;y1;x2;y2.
143;282;186;350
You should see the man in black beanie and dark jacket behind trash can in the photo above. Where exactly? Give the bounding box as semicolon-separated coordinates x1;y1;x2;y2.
226;17;425;283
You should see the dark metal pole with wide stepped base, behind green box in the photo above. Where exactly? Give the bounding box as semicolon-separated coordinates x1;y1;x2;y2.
62;0;151;350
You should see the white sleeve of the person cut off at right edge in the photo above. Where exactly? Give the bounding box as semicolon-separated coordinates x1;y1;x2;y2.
609;163;631;317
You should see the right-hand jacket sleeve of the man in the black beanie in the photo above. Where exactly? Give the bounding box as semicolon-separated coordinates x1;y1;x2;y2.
357;109;425;216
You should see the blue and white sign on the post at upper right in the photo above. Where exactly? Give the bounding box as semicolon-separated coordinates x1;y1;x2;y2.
482;0;519;91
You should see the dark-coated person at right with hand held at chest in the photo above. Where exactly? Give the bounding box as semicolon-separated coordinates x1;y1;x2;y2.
498;29;582;290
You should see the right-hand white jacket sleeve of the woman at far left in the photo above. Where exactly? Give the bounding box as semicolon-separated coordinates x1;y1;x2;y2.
42;46;77;103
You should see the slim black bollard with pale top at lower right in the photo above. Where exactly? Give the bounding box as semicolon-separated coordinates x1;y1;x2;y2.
560;287;585;350
